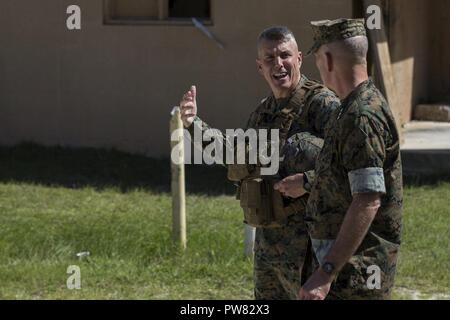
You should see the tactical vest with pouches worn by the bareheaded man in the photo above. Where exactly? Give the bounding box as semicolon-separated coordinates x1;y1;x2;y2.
228;79;323;228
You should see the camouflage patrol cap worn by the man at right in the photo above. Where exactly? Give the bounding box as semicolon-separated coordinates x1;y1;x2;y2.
306;18;366;55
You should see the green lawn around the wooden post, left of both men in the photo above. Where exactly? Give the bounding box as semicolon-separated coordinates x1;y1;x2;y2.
0;184;252;299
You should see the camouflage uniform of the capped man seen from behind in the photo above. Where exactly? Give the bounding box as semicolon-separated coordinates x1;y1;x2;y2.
305;80;403;299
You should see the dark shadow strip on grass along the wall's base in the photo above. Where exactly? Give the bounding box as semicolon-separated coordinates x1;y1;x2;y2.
0;143;235;195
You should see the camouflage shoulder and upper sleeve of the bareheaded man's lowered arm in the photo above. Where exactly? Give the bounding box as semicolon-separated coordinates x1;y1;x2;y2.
308;90;341;137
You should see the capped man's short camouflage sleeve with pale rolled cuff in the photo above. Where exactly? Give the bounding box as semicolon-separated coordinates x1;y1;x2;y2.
340;116;386;194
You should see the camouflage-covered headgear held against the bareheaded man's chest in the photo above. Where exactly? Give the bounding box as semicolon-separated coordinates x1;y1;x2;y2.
280;132;323;175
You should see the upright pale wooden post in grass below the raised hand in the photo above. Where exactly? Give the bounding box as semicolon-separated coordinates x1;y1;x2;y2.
170;107;186;249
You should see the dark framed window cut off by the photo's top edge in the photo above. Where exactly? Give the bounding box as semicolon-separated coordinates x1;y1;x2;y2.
105;0;211;23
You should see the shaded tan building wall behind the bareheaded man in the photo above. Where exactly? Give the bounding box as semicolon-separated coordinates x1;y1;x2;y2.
0;0;352;156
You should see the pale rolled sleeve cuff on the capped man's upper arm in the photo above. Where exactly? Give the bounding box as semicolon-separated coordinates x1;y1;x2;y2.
348;167;386;195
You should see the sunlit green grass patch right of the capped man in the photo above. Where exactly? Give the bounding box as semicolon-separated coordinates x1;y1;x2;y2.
396;182;450;299
